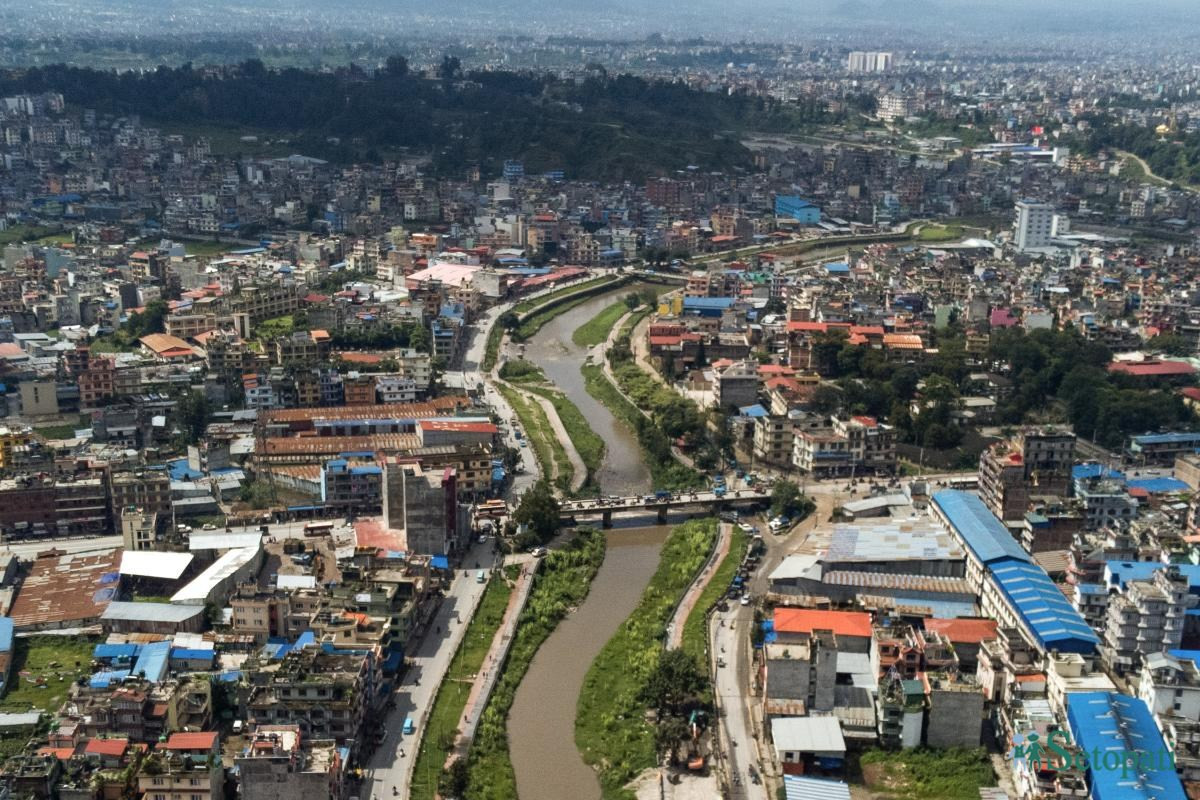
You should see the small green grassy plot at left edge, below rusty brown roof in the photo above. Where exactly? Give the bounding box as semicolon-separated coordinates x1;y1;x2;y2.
0;636;95;712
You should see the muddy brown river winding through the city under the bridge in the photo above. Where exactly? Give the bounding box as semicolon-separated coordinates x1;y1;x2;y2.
509;287;670;800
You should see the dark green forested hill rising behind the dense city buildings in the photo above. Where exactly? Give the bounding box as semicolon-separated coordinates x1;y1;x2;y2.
0;56;827;180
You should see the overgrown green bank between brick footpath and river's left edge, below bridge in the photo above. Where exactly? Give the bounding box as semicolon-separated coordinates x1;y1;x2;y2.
466;530;605;800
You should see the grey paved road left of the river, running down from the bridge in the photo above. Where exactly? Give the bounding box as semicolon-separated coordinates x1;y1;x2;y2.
360;543;494;800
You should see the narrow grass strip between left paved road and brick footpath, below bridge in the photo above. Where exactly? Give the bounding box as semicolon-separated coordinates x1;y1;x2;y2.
410;577;512;800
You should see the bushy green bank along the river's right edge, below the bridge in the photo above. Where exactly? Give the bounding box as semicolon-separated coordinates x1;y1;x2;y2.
575;519;716;800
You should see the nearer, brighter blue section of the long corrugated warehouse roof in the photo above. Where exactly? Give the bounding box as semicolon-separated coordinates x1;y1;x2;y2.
988;561;1100;654
